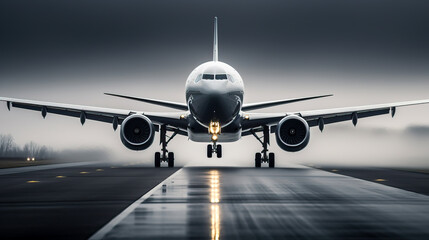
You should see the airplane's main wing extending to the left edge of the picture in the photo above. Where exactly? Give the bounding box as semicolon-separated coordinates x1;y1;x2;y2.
0;97;187;130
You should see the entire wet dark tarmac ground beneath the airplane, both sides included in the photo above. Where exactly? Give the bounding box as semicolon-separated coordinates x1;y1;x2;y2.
0;164;429;239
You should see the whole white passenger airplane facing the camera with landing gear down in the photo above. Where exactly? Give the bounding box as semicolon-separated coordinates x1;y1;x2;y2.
0;17;429;168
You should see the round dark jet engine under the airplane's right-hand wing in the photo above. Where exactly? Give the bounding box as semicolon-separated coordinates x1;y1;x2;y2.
276;115;310;152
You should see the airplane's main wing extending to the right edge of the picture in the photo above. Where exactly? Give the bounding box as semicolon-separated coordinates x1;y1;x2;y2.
242;99;429;135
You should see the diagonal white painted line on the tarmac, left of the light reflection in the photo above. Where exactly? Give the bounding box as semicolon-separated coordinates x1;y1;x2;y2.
88;168;183;240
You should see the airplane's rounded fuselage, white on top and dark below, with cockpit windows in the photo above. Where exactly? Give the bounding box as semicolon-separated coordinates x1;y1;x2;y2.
186;61;244;142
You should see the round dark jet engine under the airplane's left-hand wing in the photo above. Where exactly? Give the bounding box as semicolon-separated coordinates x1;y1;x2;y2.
120;114;155;151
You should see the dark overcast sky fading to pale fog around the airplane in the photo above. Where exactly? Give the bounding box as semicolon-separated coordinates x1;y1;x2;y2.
0;0;429;166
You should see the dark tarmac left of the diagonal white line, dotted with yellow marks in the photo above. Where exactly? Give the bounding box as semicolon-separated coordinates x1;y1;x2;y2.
0;164;177;240
